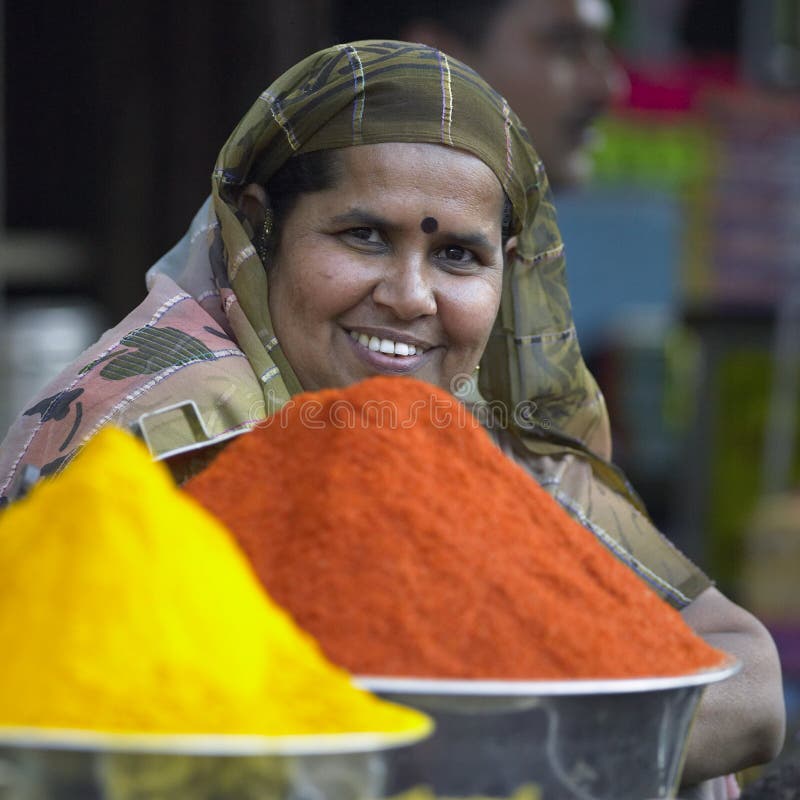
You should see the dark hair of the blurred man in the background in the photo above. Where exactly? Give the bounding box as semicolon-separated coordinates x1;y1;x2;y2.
331;0;509;47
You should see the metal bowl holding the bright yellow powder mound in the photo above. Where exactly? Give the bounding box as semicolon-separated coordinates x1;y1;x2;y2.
0;728;424;800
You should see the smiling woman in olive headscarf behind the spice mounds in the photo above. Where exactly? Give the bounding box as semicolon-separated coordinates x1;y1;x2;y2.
0;41;783;780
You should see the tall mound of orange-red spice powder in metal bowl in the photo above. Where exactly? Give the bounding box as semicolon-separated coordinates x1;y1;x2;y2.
184;378;724;680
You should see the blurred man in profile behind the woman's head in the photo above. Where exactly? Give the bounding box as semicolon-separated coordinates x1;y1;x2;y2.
333;0;627;189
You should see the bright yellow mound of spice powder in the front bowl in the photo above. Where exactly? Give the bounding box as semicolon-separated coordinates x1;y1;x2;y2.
0;428;428;736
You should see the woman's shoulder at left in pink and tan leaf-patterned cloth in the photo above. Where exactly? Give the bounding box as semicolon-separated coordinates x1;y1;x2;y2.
0;276;264;502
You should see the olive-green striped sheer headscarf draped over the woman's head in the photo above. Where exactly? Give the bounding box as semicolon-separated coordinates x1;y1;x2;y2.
170;41;620;476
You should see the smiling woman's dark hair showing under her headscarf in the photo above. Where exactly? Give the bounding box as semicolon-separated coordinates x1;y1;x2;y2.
264;150;514;253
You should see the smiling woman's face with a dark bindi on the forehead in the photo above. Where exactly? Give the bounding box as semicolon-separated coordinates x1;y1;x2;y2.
269;143;503;391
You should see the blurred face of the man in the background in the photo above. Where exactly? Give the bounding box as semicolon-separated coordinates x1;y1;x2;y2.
463;0;625;187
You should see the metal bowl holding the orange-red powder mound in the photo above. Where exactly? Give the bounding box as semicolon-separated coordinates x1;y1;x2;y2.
358;659;740;800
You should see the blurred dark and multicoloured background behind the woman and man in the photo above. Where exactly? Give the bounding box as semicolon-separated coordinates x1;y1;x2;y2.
0;0;800;736
